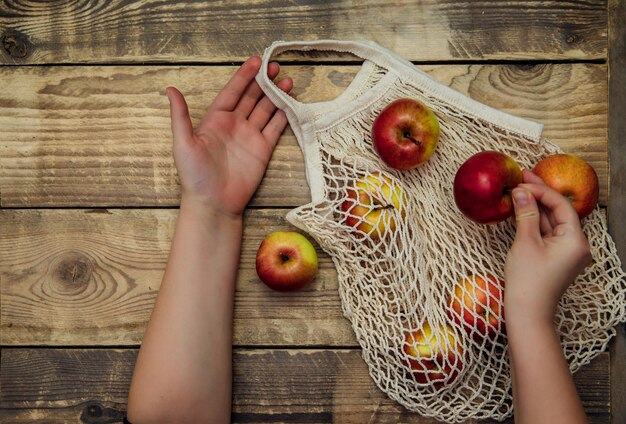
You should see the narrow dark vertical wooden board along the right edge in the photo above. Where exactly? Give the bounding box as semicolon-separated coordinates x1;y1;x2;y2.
608;0;626;424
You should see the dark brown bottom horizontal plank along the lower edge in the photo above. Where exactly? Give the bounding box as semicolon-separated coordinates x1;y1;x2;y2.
0;349;609;424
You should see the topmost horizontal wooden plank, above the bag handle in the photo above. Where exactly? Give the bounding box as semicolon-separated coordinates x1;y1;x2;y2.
0;0;607;64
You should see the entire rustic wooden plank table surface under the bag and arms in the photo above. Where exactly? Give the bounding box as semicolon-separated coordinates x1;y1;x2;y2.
0;0;626;423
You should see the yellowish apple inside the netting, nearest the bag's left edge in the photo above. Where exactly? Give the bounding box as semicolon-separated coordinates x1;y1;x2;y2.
341;172;404;240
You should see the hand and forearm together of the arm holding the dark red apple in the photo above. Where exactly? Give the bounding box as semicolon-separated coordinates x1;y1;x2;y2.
504;171;591;424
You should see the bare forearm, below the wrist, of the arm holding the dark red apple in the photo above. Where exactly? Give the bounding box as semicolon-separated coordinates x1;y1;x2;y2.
506;312;587;424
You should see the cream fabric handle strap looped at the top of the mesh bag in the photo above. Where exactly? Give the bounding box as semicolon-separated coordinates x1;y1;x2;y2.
256;40;389;113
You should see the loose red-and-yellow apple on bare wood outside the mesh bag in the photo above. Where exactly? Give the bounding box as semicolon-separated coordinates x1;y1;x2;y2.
256;231;317;291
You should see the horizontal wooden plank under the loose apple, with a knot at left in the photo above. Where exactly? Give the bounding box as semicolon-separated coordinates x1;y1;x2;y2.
0;209;356;346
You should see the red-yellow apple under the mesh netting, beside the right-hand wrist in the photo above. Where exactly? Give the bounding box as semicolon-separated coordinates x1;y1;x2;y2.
448;275;504;339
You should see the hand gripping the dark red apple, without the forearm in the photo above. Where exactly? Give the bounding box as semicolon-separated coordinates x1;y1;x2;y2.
504;171;591;327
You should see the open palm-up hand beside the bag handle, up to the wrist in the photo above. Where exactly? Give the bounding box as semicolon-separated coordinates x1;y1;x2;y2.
167;56;293;216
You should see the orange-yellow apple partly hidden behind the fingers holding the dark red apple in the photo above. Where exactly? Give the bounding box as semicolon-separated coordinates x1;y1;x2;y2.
533;153;600;219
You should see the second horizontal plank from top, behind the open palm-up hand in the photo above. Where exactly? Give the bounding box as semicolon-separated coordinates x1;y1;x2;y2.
0;64;608;207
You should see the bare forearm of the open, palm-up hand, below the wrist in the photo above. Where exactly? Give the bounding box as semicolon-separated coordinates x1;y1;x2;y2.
129;199;242;423
